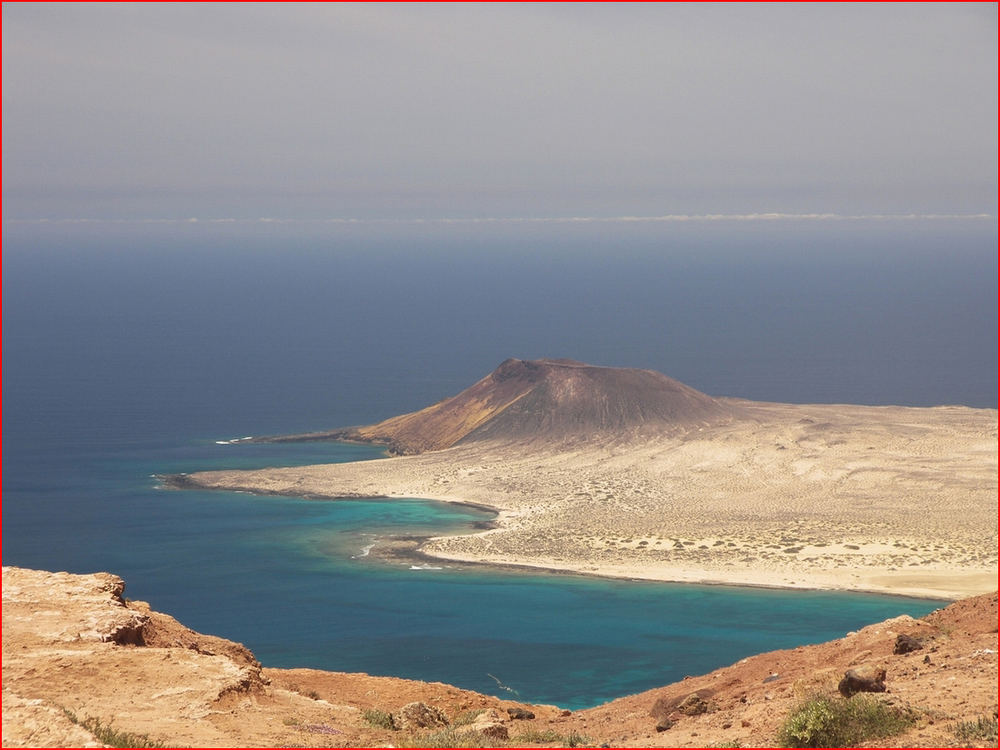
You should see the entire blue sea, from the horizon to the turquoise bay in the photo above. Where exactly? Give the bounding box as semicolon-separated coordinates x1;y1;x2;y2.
3;222;997;708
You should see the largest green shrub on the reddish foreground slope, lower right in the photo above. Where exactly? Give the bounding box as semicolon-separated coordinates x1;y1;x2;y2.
778;694;915;747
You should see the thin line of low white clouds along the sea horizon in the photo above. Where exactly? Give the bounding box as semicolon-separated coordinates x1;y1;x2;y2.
3;212;997;225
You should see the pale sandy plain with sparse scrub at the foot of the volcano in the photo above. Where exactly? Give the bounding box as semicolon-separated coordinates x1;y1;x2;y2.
181;399;997;598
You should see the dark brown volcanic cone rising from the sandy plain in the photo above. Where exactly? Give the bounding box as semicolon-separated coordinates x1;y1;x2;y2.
308;359;733;453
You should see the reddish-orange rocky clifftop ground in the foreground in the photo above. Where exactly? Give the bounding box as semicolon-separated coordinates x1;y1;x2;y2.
3;567;997;747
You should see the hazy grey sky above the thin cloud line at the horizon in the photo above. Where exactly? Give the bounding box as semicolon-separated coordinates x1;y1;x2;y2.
3;3;997;220
